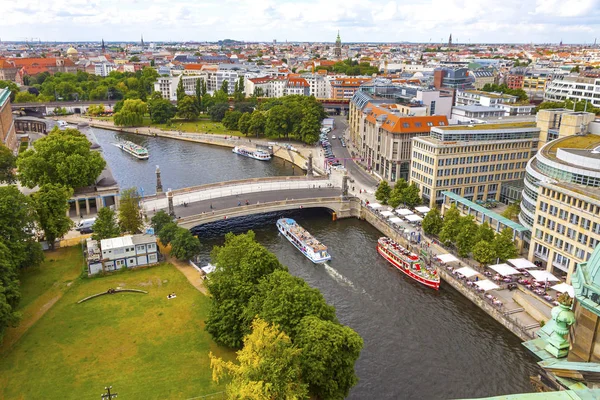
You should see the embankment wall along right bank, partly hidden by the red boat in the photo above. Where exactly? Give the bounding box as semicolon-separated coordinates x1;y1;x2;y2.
359;205;533;341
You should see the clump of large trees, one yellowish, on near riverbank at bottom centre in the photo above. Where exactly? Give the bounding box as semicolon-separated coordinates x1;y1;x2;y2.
204;228;363;399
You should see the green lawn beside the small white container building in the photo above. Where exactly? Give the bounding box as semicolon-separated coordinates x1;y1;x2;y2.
0;255;234;399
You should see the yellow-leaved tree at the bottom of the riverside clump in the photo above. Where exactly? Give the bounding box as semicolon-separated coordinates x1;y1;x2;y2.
209;319;308;400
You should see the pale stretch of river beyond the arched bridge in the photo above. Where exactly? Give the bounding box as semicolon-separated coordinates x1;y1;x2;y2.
84;128;303;195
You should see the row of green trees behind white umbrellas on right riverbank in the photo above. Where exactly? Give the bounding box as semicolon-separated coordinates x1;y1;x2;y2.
422;204;518;266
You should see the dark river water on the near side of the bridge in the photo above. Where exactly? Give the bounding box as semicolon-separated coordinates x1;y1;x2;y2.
195;210;538;399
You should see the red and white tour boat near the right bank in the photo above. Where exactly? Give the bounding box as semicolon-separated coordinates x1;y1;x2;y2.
377;237;440;290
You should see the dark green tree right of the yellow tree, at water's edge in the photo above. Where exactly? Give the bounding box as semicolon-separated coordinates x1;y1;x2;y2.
294;316;364;400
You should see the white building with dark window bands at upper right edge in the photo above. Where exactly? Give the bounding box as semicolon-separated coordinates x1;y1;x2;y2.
544;76;600;108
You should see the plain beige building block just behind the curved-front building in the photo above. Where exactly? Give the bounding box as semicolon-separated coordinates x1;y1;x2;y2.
536;108;596;145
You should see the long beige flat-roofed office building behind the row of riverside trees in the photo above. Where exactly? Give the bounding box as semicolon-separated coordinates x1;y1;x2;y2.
410;122;540;207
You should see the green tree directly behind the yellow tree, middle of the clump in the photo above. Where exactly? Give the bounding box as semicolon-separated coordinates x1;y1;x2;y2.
244;271;337;338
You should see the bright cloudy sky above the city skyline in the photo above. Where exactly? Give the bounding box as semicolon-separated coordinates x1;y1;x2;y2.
0;0;600;43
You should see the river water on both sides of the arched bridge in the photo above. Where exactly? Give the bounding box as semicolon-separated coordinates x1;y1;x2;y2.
92;129;537;399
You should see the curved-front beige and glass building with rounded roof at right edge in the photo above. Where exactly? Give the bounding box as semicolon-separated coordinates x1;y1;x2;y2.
519;121;600;283
